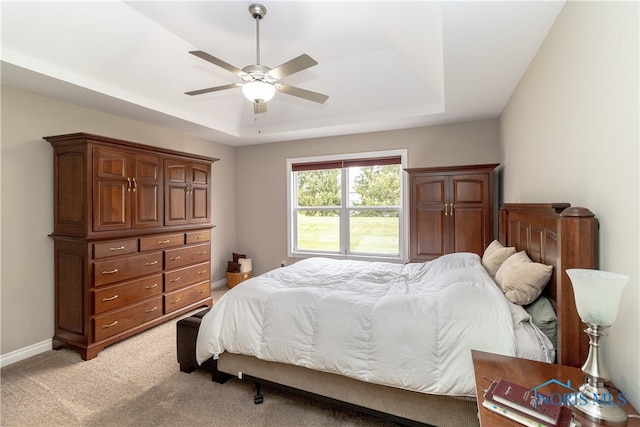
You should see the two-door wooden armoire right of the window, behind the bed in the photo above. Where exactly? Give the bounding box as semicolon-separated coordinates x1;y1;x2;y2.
406;164;498;262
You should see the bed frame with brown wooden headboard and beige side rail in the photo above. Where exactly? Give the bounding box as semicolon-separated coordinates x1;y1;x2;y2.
206;203;598;426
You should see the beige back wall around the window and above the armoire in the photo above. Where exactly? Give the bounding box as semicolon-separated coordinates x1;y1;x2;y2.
236;120;500;274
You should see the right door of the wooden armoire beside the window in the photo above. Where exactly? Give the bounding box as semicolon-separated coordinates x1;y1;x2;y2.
449;174;493;254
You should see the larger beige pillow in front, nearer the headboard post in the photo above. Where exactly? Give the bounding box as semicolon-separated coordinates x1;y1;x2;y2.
495;251;553;305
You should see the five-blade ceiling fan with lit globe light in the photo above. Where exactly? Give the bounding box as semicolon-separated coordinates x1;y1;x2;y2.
185;4;329;114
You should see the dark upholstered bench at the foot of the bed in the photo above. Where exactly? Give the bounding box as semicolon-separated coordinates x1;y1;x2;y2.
176;307;230;383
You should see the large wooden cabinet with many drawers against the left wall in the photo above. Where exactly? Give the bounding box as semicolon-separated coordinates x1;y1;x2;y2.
44;133;217;360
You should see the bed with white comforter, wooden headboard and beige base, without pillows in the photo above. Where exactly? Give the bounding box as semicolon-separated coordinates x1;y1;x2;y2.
192;203;598;426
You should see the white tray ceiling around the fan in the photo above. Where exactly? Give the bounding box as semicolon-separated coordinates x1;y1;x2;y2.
1;0;564;145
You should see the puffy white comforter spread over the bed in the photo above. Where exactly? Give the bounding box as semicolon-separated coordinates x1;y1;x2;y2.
196;253;516;396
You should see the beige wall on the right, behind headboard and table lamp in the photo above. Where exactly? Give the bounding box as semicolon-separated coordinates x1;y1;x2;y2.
501;2;640;409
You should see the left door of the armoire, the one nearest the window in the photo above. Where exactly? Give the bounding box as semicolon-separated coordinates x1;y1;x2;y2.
410;175;450;261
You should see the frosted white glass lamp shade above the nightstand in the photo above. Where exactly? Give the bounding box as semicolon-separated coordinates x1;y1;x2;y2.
567;268;629;326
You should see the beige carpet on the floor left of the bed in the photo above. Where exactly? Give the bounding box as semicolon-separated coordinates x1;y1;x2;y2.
0;290;393;427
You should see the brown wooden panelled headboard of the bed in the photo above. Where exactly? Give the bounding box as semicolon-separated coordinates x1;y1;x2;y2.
498;203;598;367
